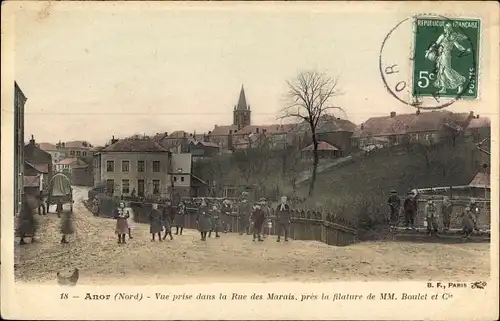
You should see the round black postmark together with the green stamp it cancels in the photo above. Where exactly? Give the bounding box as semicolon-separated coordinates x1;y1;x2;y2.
379;14;481;110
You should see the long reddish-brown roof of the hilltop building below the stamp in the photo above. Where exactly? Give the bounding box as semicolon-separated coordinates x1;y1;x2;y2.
352;111;457;137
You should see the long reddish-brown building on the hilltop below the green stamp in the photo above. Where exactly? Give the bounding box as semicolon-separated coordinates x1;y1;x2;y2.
352;111;474;149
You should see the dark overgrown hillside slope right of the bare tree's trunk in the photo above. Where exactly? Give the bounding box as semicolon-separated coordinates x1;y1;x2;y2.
299;141;489;228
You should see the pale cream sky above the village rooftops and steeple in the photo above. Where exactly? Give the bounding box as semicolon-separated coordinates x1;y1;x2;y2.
9;2;498;145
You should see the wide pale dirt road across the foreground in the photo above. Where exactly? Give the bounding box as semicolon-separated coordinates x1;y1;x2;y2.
15;187;490;285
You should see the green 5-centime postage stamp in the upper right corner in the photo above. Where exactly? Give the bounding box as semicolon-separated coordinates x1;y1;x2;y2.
412;17;481;100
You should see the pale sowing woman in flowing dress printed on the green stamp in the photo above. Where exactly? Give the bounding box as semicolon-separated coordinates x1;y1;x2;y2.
425;23;471;93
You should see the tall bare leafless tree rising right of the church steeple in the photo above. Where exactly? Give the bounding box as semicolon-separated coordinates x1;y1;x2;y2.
282;71;343;196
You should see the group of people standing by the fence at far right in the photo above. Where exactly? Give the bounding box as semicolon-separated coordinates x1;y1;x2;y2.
387;190;480;238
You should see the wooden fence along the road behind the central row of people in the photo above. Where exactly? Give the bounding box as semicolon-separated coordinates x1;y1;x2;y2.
87;197;357;246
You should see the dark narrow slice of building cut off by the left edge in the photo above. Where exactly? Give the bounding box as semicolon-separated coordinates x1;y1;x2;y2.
14;82;28;214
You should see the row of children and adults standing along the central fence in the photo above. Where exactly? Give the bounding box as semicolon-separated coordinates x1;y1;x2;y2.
114;192;291;244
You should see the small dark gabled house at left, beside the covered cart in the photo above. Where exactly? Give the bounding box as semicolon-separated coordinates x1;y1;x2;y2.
23;135;53;189
